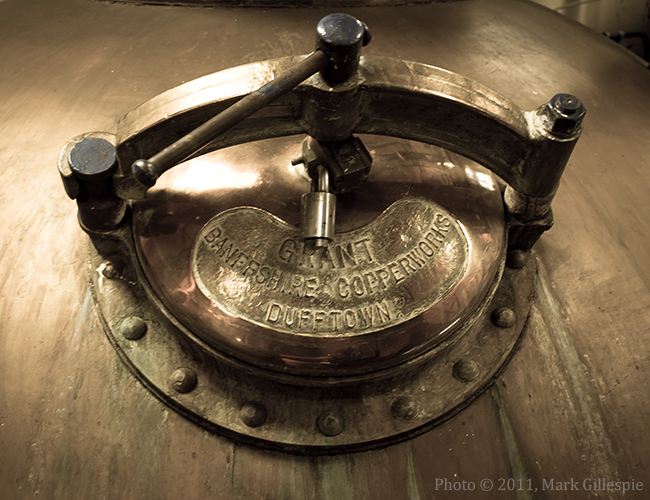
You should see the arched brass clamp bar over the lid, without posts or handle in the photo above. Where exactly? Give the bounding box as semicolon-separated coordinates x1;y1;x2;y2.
115;56;536;199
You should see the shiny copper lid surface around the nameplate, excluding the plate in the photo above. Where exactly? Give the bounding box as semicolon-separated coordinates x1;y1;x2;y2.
133;136;505;377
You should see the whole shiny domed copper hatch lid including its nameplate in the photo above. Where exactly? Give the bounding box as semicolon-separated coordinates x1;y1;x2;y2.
133;136;505;376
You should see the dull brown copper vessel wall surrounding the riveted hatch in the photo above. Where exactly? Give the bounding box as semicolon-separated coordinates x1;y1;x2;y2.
0;0;650;500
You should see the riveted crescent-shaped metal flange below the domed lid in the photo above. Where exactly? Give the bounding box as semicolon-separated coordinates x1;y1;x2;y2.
89;213;536;454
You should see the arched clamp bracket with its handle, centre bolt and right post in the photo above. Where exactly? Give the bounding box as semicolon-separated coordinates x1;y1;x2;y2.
60;14;585;247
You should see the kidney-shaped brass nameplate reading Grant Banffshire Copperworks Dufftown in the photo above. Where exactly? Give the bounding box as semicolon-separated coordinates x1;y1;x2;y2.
192;198;468;335
